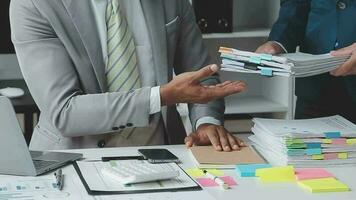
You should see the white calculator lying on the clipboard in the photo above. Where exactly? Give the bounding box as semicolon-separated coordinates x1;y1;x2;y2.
101;160;179;184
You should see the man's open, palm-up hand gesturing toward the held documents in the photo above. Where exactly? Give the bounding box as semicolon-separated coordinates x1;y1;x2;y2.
160;65;246;105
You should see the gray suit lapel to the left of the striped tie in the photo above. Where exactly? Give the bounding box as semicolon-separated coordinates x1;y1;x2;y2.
63;0;107;92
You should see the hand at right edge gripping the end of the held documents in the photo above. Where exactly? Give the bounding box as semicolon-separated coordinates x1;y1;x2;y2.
330;43;356;76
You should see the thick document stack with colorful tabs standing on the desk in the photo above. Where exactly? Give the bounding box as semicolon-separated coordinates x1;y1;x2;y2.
250;115;356;167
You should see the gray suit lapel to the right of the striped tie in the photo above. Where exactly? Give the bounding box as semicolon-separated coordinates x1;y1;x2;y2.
141;0;168;85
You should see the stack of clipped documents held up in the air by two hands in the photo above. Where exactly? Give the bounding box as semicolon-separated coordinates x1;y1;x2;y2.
219;47;350;77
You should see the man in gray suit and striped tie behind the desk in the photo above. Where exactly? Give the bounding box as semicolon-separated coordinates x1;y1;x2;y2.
10;0;245;151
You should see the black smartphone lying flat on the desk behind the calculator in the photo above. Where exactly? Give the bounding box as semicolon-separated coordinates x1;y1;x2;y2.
138;149;180;163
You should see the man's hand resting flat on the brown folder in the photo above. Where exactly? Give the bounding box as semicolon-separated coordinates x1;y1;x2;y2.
184;124;246;151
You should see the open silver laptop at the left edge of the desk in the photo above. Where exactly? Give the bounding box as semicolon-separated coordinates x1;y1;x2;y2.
0;96;83;176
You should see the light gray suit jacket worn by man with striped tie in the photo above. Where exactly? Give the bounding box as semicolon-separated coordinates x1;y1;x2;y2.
10;0;224;149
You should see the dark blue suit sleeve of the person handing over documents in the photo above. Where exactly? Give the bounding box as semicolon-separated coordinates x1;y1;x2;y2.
268;0;310;52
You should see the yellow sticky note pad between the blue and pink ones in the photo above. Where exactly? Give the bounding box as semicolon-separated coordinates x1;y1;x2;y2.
256;166;296;183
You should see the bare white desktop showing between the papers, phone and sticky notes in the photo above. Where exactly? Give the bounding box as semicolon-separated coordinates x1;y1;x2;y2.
61;145;356;200
